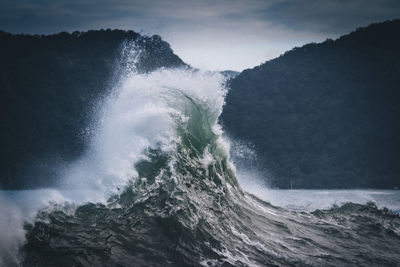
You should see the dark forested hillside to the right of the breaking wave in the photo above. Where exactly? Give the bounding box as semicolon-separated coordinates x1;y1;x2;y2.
222;20;400;188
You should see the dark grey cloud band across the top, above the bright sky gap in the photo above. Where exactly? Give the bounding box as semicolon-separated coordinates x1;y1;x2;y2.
0;0;400;33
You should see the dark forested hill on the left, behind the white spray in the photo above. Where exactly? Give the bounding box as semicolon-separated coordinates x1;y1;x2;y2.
0;30;184;189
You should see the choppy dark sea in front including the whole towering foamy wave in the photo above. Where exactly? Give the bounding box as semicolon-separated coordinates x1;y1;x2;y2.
0;47;400;266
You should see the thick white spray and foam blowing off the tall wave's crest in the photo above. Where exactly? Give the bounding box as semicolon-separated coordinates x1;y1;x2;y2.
59;69;225;198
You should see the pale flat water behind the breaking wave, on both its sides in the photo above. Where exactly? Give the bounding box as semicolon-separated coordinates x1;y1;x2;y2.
0;189;400;222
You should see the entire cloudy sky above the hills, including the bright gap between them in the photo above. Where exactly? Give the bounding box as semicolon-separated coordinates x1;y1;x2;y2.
0;0;400;71
